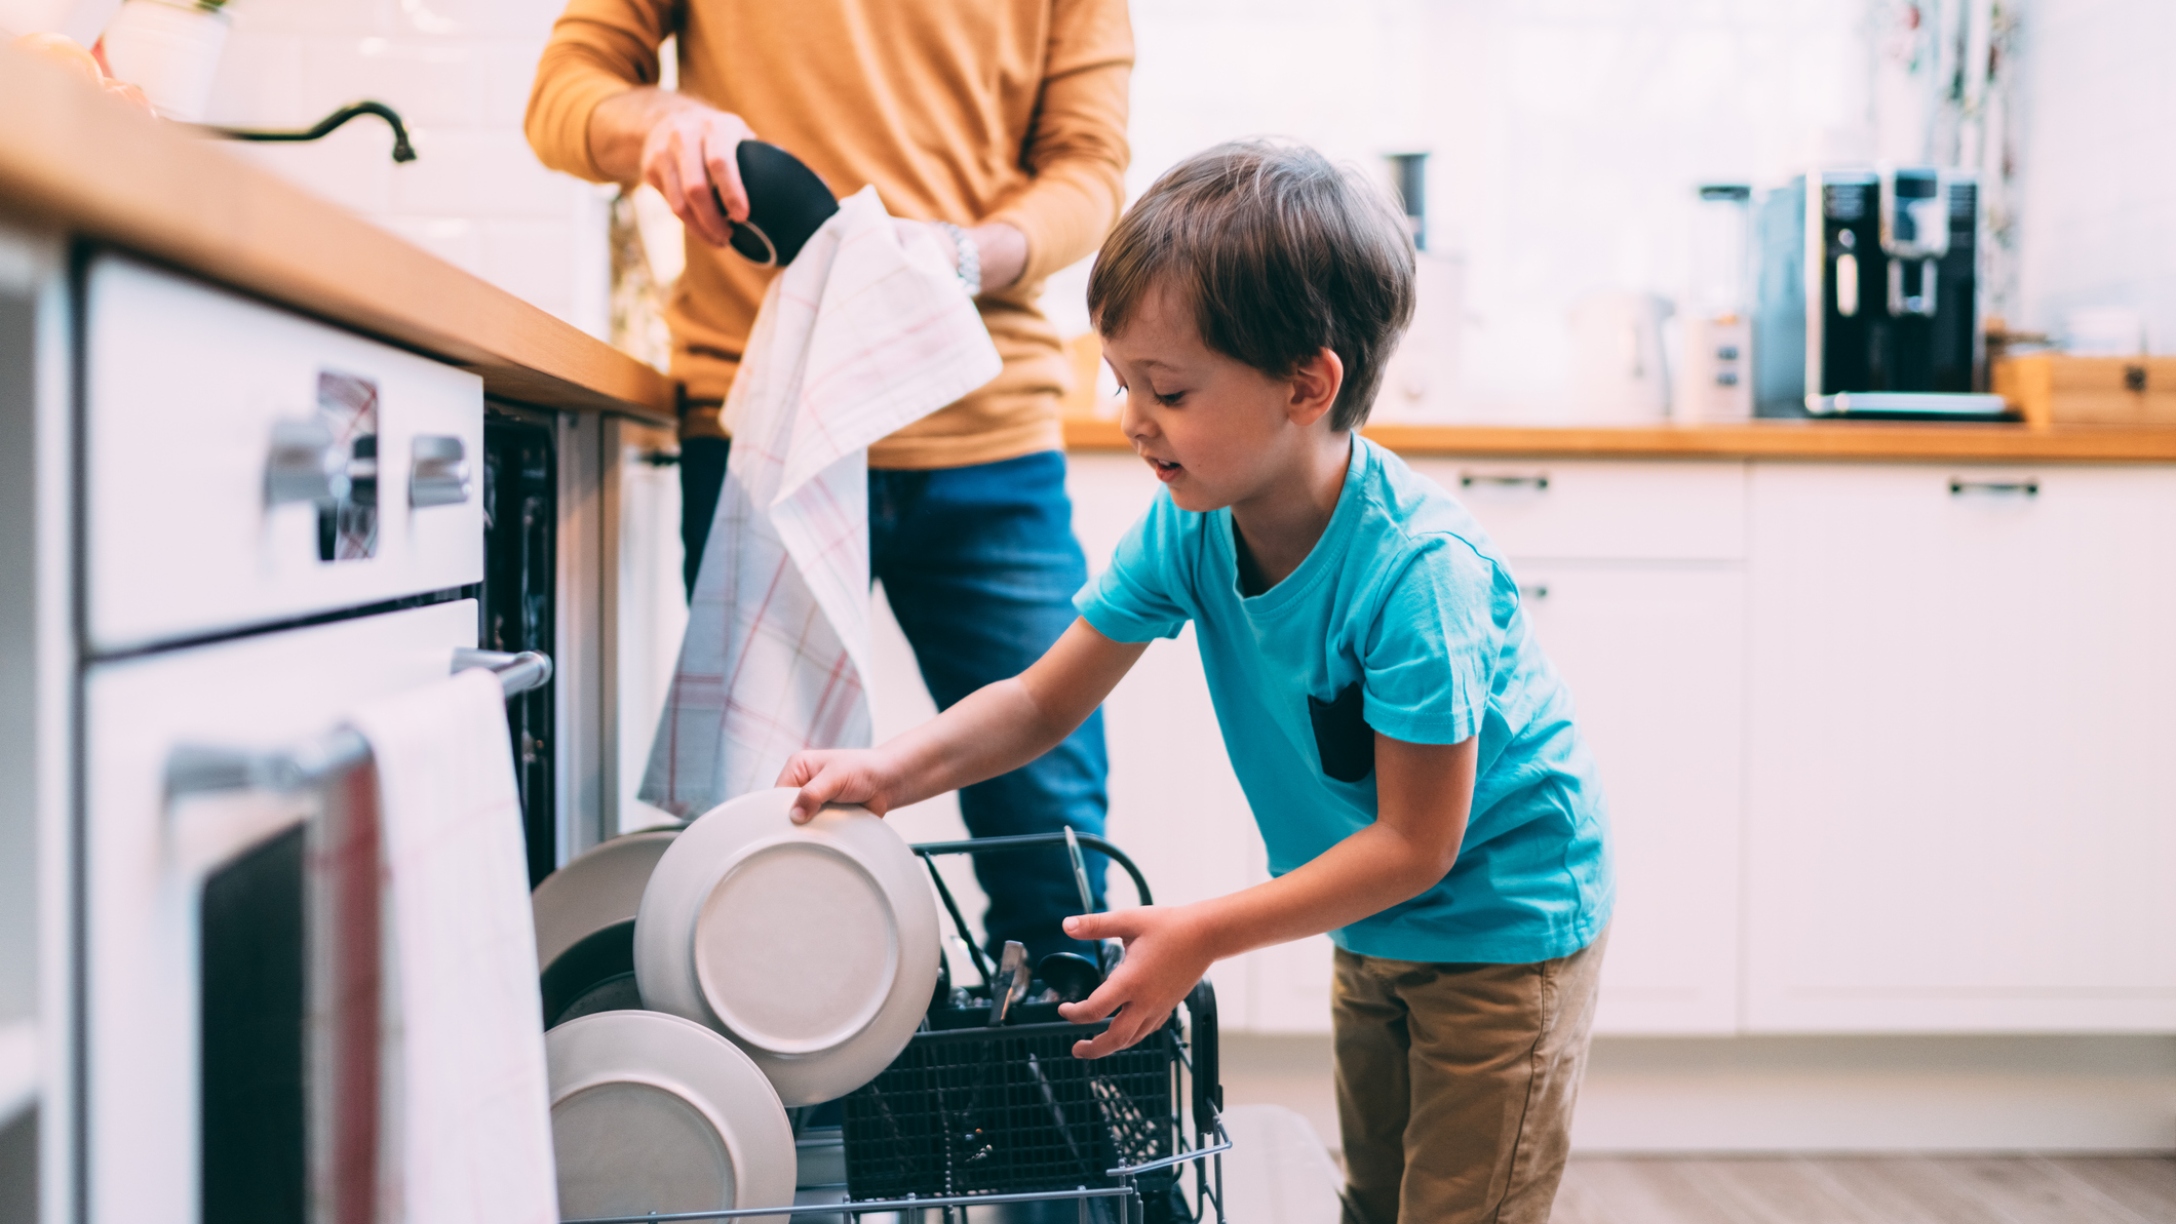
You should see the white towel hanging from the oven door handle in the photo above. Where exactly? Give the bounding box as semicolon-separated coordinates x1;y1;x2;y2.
353;671;559;1224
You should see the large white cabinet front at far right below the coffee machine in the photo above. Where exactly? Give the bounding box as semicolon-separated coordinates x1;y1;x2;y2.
1745;464;2176;1032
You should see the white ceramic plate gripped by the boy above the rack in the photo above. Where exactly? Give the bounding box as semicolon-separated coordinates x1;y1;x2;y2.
635;788;940;1106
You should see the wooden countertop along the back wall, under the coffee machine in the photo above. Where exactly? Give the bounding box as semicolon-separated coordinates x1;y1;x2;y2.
1066;418;2176;464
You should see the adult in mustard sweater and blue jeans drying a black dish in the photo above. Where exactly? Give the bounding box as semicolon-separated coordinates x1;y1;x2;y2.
527;0;1134;956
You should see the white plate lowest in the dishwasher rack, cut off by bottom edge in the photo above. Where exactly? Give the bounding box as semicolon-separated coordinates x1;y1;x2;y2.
544;1011;794;1224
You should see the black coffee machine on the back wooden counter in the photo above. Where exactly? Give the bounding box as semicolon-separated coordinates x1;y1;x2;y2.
1754;168;2006;418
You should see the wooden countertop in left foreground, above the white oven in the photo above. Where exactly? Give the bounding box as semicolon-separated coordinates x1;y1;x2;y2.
0;46;672;420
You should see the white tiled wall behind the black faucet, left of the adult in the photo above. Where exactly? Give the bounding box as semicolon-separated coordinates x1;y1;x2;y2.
209;0;609;335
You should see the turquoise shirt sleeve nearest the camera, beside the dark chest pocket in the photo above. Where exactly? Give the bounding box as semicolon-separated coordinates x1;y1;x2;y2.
1360;536;1504;743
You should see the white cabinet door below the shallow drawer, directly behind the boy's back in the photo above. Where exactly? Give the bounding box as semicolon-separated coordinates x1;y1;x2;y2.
1512;562;1745;1035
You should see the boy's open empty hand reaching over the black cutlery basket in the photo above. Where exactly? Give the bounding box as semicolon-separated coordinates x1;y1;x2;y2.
1058;906;1216;1058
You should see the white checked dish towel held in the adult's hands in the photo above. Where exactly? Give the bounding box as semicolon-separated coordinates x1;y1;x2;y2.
640;187;1001;817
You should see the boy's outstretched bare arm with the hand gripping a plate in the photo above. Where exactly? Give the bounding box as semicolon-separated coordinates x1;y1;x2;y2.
779;621;1149;823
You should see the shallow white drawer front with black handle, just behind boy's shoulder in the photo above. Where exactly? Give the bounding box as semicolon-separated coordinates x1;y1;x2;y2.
1410;457;1745;562
